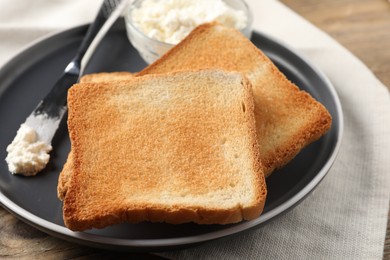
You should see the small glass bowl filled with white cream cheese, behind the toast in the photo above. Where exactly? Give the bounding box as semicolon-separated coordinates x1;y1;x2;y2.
125;0;252;63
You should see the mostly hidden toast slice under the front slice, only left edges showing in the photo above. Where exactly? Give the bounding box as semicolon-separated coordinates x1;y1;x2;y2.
57;71;134;200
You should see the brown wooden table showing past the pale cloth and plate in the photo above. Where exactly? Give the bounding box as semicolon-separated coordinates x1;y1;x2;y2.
0;0;390;259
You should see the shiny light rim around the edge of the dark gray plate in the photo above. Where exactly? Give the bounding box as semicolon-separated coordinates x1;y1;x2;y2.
0;21;344;251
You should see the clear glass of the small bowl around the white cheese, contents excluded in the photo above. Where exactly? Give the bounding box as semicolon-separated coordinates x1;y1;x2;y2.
124;0;253;64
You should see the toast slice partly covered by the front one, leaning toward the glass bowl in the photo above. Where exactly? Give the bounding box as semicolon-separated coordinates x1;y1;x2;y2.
137;23;332;176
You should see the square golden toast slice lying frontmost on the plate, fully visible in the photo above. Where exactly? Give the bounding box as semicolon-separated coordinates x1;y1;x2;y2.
63;70;266;231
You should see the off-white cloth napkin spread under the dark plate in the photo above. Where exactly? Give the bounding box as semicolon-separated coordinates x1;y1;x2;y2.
0;0;390;259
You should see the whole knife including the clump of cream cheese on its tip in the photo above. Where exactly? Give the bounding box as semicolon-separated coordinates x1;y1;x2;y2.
5;0;127;176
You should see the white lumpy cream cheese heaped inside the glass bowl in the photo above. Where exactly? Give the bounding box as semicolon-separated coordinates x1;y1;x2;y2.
132;0;248;44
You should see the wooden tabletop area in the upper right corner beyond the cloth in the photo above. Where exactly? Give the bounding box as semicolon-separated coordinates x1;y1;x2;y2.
281;0;390;89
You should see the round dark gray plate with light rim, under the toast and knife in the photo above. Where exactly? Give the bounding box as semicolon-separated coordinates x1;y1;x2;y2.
0;20;343;251
